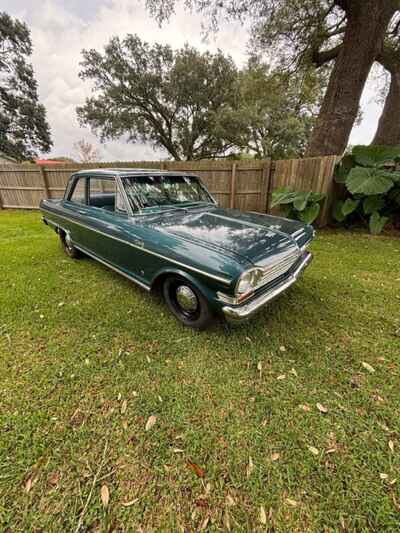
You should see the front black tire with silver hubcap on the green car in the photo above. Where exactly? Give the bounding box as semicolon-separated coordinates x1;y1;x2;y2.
163;276;214;330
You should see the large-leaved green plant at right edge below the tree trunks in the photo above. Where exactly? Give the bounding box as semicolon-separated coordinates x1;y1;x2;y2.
333;146;400;234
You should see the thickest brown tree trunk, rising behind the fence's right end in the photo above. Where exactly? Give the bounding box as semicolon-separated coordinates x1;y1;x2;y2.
306;0;395;156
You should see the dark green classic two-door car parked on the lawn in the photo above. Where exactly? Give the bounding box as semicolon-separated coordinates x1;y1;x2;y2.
40;168;314;329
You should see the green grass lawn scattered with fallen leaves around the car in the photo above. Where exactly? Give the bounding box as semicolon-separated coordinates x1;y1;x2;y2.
0;211;400;532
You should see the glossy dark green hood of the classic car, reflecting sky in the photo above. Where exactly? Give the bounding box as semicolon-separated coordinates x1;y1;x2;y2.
142;207;314;264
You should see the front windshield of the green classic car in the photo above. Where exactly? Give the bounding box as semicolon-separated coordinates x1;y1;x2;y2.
123;175;213;209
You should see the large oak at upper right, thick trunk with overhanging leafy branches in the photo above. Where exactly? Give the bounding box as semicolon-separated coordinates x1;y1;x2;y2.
147;0;400;155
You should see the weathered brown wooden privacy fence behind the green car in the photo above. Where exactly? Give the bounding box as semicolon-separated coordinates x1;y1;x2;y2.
0;156;338;226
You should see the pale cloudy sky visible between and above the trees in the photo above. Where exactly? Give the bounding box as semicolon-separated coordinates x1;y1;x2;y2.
1;0;381;161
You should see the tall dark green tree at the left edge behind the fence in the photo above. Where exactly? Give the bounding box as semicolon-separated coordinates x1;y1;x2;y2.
0;13;52;160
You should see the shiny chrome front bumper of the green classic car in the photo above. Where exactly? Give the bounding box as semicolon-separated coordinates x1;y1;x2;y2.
222;252;312;322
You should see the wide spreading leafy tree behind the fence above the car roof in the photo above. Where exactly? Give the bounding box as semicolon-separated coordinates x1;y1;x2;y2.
77;35;245;160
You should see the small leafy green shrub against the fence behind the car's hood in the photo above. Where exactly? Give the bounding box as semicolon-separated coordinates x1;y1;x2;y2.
271;187;325;224
